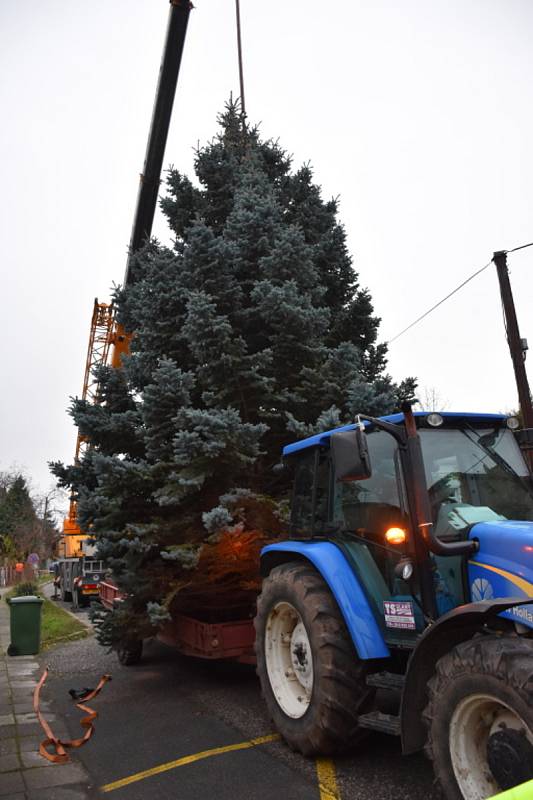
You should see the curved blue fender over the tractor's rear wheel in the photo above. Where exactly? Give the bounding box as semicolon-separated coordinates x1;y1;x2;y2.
261;541;390;660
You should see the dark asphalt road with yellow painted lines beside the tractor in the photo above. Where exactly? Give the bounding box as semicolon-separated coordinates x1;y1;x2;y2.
38;592;440;800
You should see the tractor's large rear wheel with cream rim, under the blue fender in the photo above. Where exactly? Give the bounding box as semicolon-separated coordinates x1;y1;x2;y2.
255;562;374;756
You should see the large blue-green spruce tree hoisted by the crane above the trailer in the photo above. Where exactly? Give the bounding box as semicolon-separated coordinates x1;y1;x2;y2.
52;103;414;643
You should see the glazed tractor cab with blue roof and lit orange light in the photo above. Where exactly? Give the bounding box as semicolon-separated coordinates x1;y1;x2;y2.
284;412;533;646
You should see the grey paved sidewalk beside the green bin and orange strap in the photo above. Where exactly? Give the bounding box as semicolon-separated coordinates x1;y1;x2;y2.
0;589;100;800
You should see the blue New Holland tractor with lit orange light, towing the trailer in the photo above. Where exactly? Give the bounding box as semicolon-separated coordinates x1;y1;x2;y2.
255;404;533;800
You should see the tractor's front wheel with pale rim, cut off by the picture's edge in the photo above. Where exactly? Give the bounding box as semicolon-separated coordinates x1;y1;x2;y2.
424;636;533;800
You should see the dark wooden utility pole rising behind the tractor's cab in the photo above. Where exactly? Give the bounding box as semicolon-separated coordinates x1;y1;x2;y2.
492;250;533;456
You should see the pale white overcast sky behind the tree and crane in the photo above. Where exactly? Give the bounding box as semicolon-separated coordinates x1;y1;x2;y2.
0;0;533;504
